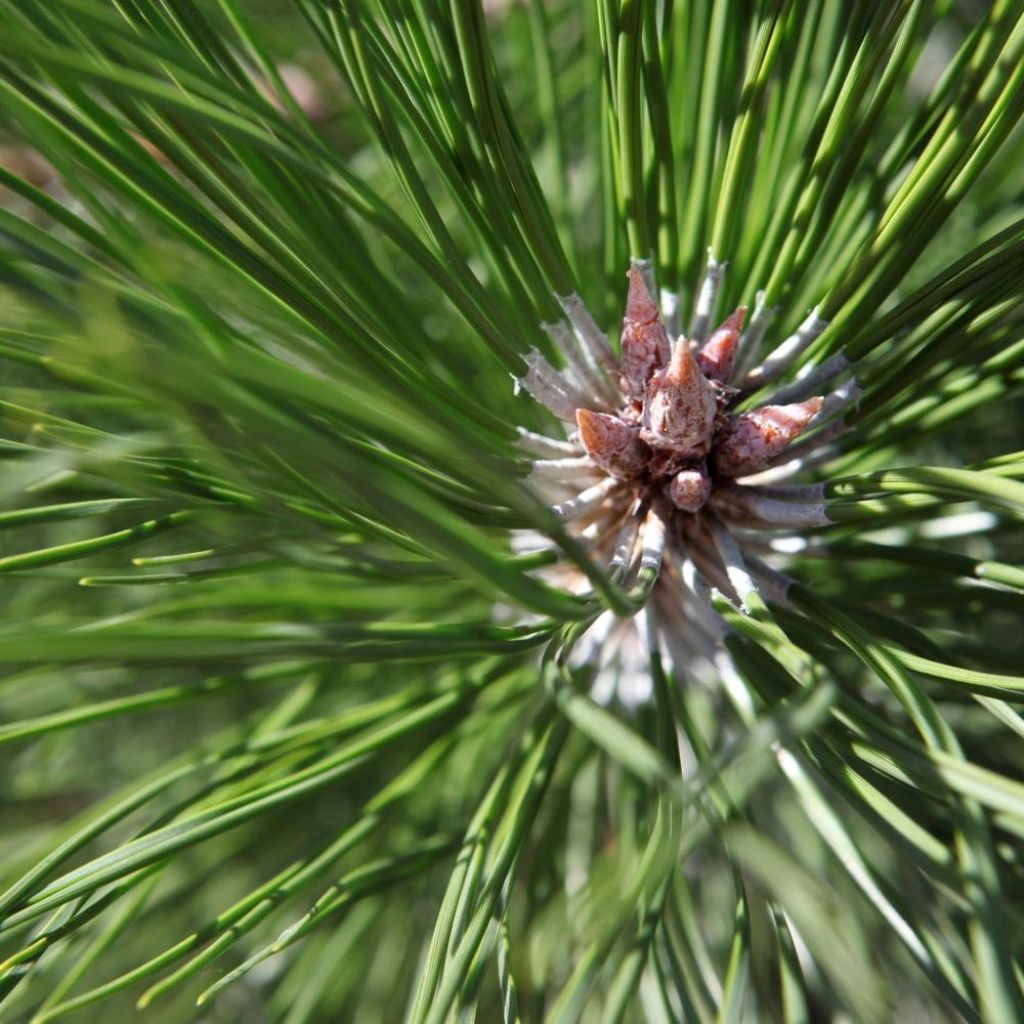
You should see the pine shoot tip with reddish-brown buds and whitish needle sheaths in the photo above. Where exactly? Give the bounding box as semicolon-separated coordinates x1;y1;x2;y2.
519;259;859;700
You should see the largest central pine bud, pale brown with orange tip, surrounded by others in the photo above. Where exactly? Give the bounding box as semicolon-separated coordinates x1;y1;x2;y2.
641;338;718;455
